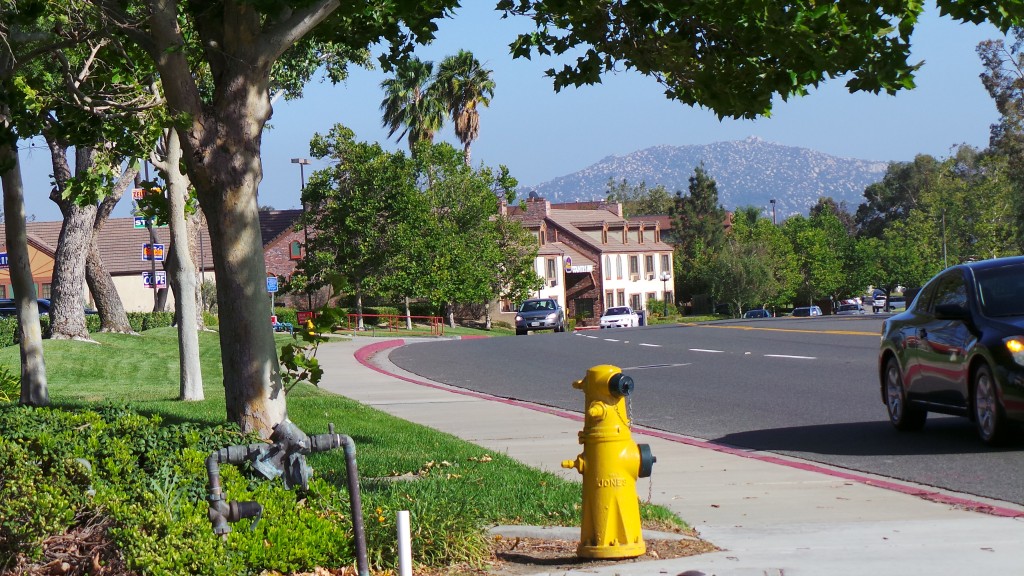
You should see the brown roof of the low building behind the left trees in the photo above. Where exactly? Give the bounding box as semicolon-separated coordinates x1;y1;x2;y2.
0;210;302;275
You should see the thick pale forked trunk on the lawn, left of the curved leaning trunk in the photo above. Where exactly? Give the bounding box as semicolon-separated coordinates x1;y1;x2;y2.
46;142;96;340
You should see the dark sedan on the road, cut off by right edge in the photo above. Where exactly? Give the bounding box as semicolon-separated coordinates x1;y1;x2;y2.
879;256;1024;445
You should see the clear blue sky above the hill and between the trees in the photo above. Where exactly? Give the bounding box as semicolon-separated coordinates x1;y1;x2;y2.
22;0;999;220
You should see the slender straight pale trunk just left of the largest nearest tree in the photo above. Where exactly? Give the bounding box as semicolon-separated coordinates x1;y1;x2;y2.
154;130;203;401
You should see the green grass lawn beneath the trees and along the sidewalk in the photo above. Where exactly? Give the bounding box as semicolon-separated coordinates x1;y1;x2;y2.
0;328;685;573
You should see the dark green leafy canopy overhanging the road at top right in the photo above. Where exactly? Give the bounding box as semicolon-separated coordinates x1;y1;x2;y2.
498;0;1024;118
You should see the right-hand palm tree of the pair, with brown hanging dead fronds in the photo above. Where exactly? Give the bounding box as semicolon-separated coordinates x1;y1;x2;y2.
433;50;495;165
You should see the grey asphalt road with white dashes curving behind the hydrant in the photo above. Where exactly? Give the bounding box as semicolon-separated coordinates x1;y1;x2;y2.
390;315;1024;504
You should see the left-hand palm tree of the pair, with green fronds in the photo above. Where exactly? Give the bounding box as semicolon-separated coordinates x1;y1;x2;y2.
381;56;444;152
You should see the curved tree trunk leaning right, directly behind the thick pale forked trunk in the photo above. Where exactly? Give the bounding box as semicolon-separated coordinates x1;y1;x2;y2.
85;167;138;334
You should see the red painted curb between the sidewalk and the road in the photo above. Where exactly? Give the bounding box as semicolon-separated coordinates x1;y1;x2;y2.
355;338;1024;518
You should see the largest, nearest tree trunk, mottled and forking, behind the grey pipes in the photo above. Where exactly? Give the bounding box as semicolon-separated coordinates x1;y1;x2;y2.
140;0;338;438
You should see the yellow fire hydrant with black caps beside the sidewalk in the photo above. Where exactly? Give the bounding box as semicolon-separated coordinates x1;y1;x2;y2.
562;364;656;559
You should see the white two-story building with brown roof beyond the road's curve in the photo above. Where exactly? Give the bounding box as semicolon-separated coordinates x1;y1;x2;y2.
495;198;674;324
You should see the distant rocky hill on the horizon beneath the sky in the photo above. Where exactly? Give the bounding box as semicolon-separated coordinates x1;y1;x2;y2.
519;137;888;216
